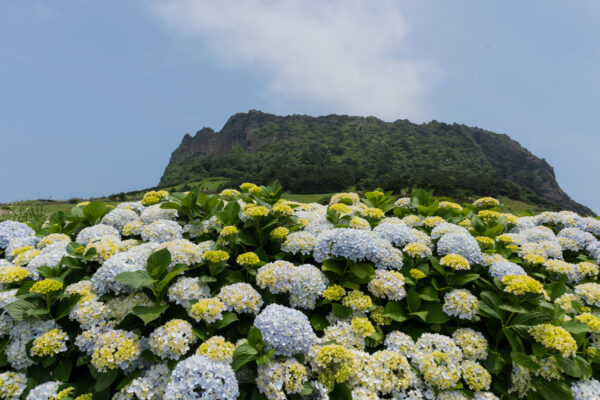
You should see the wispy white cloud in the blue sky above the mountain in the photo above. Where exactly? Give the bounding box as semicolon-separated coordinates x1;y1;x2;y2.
153;0;433;120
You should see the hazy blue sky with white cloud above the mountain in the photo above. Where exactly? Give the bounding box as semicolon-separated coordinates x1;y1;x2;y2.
0;0;600;212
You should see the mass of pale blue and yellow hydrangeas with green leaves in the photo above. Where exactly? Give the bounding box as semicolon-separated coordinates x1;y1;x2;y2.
0;183;600;400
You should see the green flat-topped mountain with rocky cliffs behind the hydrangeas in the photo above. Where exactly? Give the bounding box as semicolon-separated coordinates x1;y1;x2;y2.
159;111;593;215
